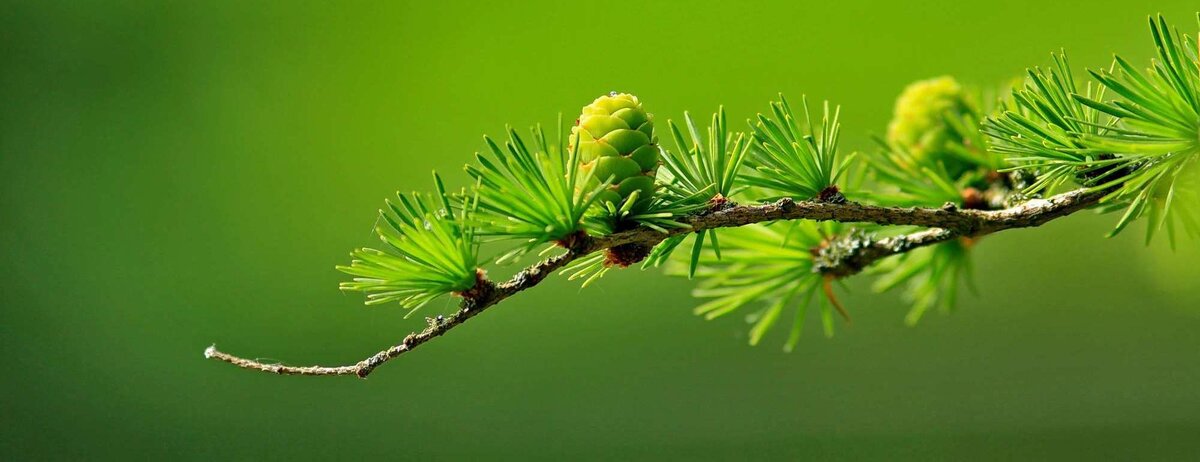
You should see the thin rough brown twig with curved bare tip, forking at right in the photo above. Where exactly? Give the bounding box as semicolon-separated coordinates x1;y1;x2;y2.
204;184;1103;378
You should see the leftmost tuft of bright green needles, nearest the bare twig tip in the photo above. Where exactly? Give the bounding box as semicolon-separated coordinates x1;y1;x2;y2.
337;174;479;311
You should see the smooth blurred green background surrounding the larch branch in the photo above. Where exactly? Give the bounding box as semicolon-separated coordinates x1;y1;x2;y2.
0;0;1200;460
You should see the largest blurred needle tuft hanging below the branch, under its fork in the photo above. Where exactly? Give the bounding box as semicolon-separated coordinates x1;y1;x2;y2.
667;221;841;350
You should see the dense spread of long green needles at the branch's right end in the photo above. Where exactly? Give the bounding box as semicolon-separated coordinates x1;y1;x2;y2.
989;16;1200;245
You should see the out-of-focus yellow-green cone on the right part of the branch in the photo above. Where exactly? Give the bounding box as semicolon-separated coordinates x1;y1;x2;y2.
888;77;970;170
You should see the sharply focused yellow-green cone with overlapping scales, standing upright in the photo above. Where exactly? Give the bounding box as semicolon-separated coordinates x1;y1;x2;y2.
571;92;659;206
